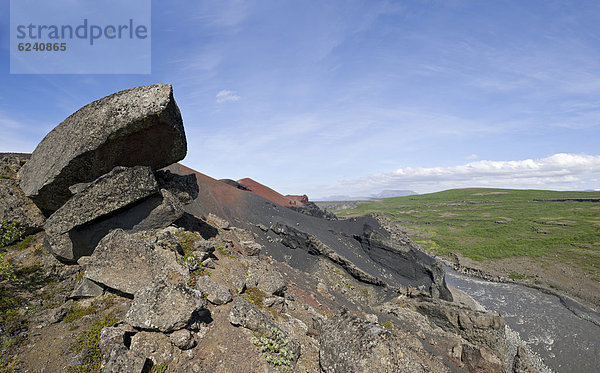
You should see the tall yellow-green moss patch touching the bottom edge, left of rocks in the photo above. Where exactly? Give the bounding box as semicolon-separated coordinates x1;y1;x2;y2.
67;313;119;373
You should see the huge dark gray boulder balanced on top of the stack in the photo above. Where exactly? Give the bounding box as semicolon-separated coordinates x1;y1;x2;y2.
19;84;187;211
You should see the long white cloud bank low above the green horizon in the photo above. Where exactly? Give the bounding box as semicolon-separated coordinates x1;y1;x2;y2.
329;153;600;195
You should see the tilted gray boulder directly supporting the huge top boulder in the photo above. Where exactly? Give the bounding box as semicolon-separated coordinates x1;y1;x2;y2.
44;166;184;263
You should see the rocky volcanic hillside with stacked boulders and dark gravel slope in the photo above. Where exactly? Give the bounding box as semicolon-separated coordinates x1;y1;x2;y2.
0;85;534;373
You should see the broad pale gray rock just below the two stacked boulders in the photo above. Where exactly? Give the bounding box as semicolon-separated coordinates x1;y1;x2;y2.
85;229;189;294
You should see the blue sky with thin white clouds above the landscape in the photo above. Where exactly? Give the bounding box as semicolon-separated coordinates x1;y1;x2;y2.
0;0;600;198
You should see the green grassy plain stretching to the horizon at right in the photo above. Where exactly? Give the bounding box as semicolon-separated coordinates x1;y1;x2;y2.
335;188;600;281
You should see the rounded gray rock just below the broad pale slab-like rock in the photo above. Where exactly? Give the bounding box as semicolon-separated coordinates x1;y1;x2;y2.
125;282;205;333
